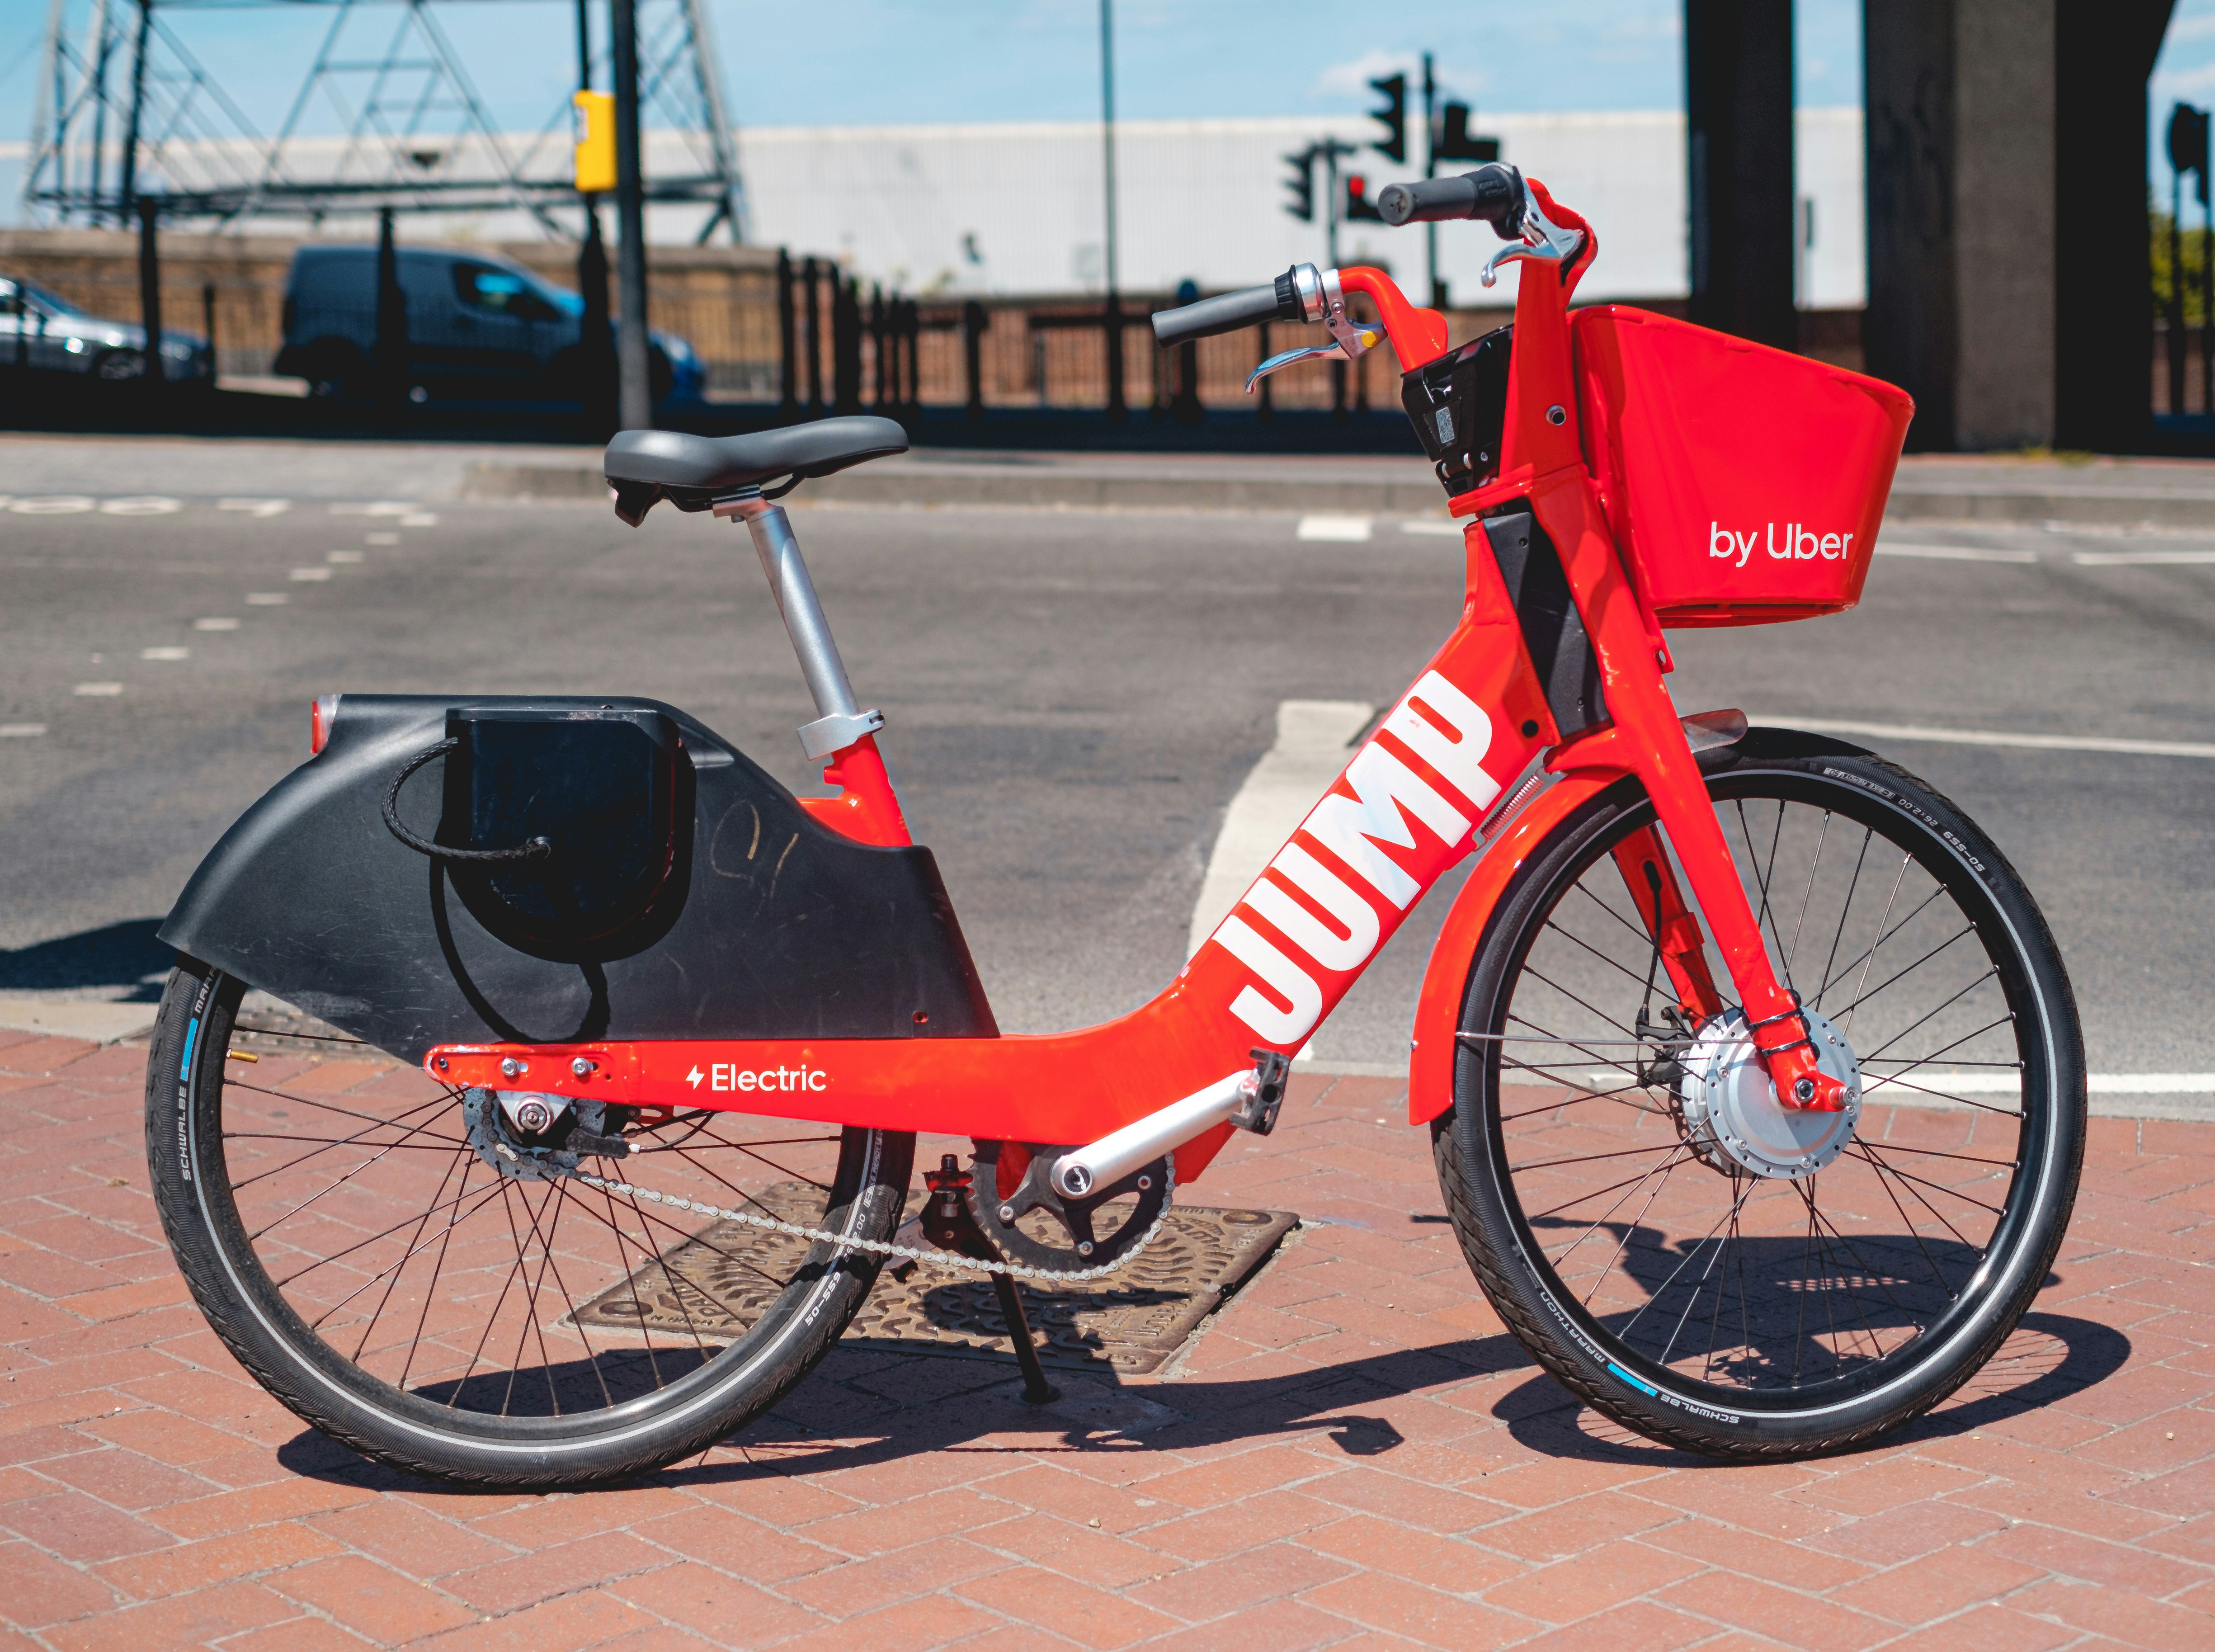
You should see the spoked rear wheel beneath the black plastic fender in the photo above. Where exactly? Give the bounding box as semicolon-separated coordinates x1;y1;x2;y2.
146;961;915;1488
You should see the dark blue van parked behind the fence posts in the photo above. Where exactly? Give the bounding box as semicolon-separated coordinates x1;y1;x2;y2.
275;246;702;403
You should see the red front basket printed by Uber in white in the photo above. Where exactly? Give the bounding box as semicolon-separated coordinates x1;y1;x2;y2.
1570;306;1916;624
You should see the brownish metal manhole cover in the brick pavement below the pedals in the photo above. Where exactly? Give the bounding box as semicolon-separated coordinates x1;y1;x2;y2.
576;1183;1300;1375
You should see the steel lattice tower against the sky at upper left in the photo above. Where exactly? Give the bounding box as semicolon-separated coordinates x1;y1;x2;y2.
22;0;746;241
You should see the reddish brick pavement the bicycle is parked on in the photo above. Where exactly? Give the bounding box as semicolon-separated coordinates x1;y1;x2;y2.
0;1034;2215;1652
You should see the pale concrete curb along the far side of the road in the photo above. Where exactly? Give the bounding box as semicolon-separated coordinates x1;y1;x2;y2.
461;463;2215;529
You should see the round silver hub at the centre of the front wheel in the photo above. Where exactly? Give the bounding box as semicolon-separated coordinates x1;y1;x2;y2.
1677;1010;1861;1180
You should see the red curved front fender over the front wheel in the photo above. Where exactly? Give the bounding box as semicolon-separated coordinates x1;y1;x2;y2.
1407;728;1870;1125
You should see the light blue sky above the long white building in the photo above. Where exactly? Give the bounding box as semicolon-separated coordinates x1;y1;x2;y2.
0;0;2215;140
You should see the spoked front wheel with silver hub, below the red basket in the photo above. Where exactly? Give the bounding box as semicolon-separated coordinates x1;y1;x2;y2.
1433;731;2087;1459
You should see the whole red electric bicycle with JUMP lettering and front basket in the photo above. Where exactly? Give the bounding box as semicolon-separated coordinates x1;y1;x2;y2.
146;166;2087;1486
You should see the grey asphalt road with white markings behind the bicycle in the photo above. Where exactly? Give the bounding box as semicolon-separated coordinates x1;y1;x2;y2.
0;443;2215;1072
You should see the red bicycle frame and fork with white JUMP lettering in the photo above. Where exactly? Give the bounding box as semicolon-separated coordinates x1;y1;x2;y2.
428;184;1841;1183
